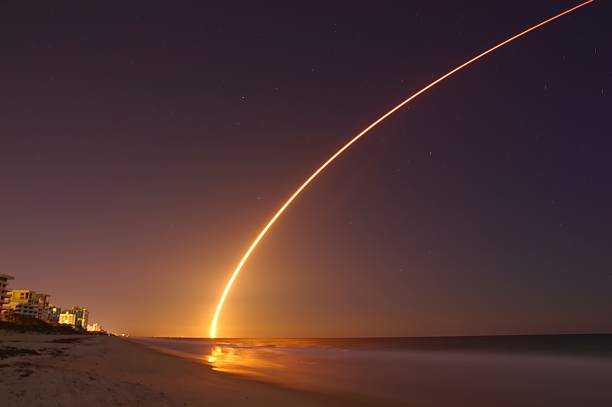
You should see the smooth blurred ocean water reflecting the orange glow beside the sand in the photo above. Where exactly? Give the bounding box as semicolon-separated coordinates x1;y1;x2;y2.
130;335;612;406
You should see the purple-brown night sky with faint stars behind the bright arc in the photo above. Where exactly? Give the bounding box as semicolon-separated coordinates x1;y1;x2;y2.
0;0;612;337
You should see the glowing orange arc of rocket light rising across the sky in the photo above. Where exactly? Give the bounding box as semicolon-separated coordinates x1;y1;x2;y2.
210;0;594;338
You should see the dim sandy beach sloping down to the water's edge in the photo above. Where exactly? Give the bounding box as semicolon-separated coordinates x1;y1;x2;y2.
0;331;375;407
